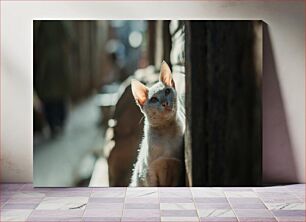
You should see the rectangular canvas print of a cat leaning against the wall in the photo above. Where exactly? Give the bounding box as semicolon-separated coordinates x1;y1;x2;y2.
33;20;262;187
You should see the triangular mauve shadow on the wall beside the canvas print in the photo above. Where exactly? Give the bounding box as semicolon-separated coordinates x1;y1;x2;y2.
263;23;298;184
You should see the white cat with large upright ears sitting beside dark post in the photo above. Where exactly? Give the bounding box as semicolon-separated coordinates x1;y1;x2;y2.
130;61;185;187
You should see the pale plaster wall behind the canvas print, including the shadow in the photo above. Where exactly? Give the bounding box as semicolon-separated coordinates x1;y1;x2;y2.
1;1;305;183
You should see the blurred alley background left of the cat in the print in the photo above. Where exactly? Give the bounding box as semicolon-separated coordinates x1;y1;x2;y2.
33;20;152;186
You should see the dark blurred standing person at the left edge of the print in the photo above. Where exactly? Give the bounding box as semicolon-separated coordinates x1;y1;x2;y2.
34;21;69;136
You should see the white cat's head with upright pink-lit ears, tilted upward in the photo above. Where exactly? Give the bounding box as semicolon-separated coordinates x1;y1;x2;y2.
131;61;177;126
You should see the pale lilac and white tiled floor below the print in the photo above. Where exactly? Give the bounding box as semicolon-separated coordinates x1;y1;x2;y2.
1;184;305;222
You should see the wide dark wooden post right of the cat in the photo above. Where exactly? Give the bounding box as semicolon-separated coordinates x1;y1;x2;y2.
185;21;262;186
